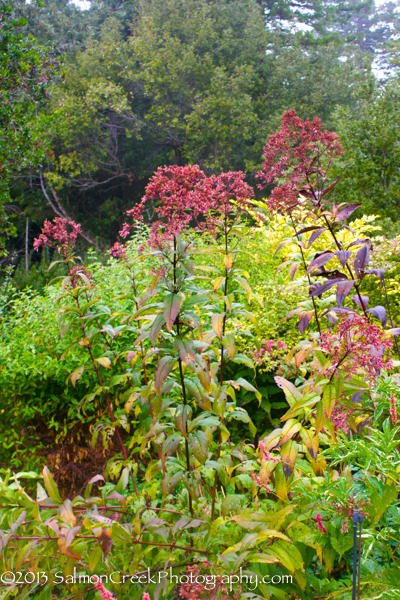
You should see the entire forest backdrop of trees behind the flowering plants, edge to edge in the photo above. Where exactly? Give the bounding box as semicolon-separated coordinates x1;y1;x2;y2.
0;0;400;266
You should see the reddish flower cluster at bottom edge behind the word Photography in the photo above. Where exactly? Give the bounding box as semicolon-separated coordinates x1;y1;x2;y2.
179;561;242;600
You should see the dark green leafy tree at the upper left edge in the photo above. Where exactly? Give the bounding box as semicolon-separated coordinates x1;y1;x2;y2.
0;2;56;253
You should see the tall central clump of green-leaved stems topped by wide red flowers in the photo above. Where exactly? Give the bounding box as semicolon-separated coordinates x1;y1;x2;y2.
21;166;312;597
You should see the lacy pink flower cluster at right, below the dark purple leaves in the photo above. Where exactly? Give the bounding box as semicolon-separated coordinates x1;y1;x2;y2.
320;313;393;384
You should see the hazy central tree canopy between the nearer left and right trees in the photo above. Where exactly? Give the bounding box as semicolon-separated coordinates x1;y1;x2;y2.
4;0;397;250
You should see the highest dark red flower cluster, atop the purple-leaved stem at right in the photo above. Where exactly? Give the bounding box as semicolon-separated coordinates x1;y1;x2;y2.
257;110;343;213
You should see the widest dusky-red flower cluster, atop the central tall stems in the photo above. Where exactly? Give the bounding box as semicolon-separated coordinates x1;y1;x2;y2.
120;165;253;245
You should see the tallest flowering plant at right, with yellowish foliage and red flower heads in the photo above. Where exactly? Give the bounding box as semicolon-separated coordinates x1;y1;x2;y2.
256;111;396;497
